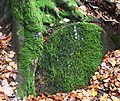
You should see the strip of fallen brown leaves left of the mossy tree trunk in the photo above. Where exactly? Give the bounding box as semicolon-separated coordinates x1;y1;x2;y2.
0;25;18;101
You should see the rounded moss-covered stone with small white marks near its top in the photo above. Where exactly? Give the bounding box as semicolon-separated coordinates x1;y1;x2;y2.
38;22;113;93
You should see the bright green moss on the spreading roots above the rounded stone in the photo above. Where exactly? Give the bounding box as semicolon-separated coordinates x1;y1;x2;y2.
36;0;90;28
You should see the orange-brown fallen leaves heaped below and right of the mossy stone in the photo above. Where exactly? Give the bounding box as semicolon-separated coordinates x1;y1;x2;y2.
23;49;120;101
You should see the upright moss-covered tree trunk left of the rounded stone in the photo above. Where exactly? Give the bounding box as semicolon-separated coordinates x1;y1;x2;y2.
11;0;45;97
